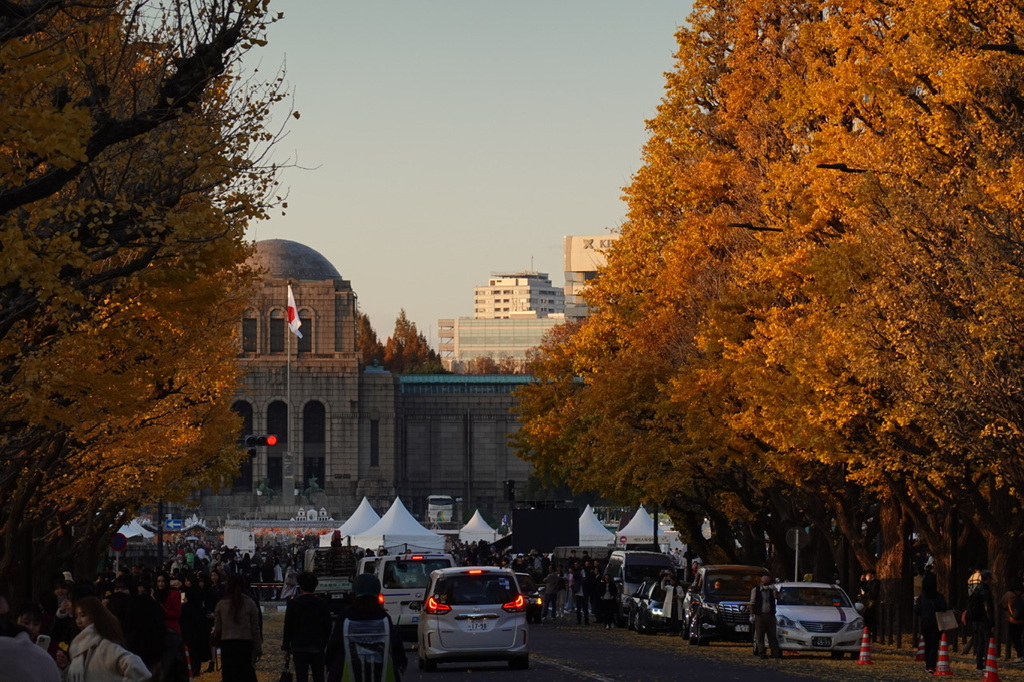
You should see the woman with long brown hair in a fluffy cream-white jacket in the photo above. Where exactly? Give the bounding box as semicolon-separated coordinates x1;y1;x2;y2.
68;597;152;682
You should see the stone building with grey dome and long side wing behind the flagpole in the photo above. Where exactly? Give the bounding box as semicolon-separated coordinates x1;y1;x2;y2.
199;240;529;519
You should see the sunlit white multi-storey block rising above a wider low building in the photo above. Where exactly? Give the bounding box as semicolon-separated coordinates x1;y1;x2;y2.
473;271;565;319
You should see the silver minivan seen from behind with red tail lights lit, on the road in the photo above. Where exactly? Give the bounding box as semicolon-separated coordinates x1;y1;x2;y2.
418;566;529;671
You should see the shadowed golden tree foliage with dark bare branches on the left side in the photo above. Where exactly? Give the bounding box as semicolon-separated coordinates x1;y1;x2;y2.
0;0;282;590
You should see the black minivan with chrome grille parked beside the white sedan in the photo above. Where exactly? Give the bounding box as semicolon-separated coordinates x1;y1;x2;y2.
683;564;768;645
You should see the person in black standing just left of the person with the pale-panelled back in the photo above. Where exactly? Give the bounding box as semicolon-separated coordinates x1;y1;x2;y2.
281;571;331;682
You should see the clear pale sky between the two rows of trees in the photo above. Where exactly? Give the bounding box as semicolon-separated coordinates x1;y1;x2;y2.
249;0;691;339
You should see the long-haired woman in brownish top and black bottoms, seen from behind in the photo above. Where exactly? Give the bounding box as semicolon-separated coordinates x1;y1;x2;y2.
211;573;263;682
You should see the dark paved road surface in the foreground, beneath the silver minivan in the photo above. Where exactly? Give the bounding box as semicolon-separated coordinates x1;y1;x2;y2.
403;625;815;682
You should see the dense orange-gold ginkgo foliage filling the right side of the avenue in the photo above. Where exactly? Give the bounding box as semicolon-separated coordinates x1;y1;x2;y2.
519;0;1024;570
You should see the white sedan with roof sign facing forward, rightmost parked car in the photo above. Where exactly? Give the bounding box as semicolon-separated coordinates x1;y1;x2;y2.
774;583;864;658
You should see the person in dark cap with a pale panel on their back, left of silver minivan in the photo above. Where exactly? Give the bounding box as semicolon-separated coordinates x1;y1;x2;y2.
327;573;409;682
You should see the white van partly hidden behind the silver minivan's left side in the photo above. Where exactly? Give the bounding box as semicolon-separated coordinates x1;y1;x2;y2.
359;552;455;642
